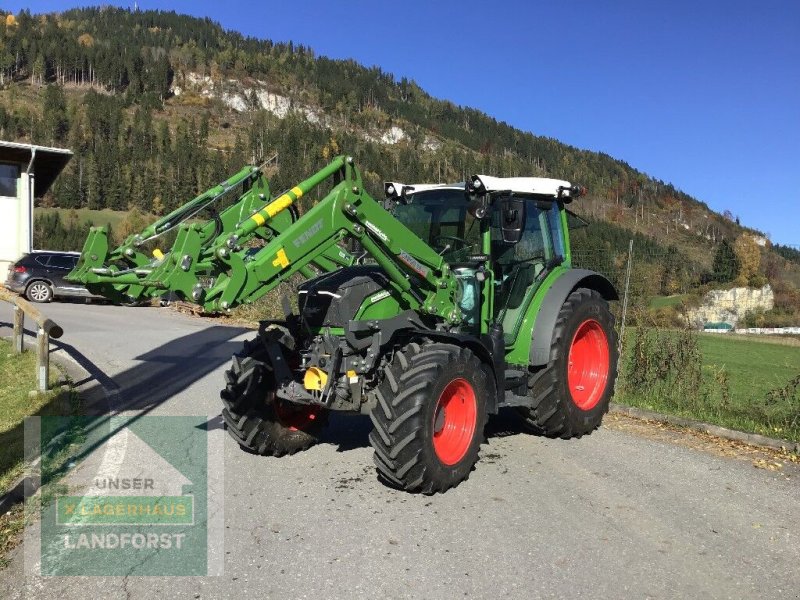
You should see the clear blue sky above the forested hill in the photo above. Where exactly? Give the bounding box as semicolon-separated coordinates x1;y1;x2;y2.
4;0;800;245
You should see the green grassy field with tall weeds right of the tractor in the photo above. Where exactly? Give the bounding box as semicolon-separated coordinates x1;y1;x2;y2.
616;329;800;441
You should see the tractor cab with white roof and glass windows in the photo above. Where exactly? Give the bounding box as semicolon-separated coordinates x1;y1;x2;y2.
386;175;581;344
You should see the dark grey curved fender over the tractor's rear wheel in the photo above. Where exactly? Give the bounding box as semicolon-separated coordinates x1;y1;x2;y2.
530;269;619;366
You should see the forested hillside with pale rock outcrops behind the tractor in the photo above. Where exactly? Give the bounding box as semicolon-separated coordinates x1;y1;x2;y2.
0;8;796;324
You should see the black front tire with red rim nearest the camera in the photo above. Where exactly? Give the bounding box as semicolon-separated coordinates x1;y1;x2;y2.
369;343;493;494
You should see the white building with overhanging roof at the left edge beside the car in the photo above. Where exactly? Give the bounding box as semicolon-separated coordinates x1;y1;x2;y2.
0;141;72;274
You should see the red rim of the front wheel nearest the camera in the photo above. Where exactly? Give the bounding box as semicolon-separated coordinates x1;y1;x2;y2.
433;377;478;465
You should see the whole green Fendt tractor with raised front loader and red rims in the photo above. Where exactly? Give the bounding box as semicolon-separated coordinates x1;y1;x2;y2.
69;156;618;494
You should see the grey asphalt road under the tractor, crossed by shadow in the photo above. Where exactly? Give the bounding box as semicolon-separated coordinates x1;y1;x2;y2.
0;303;800;599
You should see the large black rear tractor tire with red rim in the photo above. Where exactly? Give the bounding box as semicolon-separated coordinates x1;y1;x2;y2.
520;288;619;439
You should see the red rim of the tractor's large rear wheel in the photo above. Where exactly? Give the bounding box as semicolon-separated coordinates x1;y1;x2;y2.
567;319;609;410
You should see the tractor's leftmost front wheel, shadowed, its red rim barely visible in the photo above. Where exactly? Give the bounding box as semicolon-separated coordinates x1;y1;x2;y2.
220;331;327;456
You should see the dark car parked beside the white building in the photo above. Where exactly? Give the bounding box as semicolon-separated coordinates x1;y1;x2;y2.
6;251;94;302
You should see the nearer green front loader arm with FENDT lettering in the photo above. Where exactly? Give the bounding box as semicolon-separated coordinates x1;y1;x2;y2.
74;156;461;323
